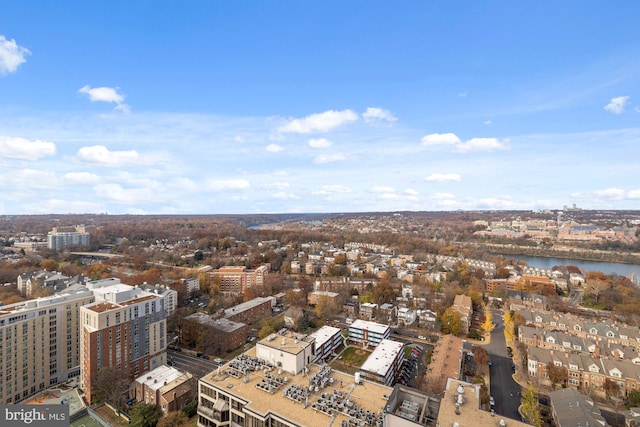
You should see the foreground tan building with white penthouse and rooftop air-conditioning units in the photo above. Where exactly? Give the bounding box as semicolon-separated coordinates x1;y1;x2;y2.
197;333;392;427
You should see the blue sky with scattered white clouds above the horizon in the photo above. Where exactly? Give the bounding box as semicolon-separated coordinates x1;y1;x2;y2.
0;0;640;214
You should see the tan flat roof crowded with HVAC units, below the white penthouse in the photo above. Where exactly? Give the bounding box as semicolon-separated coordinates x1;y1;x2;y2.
200;348;392;427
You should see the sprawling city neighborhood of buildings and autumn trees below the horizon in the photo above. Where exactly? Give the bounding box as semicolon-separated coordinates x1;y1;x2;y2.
0;211;640;427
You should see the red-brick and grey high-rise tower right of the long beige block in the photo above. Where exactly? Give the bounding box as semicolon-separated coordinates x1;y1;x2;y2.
80;281;167;403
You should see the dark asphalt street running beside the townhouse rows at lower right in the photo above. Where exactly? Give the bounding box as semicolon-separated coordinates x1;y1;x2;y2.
484;310;522;420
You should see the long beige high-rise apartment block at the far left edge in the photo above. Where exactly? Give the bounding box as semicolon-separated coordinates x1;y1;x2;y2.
0;285;95;403
